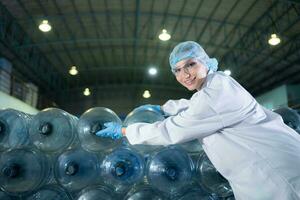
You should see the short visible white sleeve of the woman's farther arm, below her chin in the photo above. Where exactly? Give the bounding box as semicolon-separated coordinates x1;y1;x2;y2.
161;99;189;116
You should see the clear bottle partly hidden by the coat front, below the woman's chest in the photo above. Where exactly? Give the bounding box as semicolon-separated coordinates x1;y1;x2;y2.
196;152;233;198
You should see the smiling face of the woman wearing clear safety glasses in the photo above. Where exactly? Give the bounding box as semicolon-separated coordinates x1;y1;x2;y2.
173;58;208;91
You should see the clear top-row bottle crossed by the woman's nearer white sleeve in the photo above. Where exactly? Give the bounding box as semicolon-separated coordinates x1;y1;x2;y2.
123;107;165;154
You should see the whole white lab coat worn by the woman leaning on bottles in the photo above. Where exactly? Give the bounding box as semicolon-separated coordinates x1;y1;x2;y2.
126;72;300;200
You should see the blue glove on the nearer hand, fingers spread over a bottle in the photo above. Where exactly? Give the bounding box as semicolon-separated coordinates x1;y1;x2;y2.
96;122;123;140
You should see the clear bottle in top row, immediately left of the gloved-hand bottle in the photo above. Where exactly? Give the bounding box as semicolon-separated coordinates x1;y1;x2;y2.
29;108;78;153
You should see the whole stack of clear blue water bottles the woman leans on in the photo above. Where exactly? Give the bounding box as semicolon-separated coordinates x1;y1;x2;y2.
0;107;298;200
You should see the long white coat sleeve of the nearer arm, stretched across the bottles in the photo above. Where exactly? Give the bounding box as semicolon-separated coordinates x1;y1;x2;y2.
126;72;255;145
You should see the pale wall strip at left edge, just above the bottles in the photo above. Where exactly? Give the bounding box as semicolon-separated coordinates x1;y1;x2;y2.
0;91;39;114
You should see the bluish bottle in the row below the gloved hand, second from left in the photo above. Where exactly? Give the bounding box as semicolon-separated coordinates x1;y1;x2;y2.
54;148;100;191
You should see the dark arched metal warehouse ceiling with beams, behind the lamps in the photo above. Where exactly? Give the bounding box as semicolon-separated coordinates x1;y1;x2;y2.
0;0;300;114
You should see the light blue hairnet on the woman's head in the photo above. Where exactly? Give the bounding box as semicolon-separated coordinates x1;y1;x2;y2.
169;41;218;72
